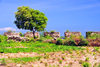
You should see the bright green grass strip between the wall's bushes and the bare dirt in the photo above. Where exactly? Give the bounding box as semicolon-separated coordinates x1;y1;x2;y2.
0;41;84;53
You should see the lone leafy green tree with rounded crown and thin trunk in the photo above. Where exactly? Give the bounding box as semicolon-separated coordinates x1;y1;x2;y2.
14;6;48;38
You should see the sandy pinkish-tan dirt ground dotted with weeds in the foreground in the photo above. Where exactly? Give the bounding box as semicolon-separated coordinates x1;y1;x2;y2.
0;47;100;67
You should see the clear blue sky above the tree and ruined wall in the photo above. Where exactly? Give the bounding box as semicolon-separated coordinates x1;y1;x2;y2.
0;0;100;36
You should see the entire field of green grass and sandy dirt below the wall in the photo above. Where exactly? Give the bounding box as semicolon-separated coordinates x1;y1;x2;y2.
0;41;100;67
